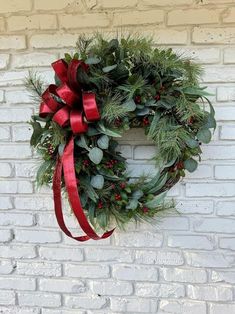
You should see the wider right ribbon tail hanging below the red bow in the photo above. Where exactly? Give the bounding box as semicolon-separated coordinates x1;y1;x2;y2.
62;138;114;240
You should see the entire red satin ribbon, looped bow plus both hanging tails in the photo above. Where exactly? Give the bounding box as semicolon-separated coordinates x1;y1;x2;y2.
40;59;114;241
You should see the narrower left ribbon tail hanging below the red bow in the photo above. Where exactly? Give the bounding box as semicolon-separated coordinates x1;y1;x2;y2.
53;158;90;242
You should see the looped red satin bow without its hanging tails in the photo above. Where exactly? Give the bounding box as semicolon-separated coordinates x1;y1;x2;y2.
39;59;100;134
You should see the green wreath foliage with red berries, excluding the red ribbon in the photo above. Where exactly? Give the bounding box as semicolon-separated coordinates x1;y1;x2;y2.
26;33;216;229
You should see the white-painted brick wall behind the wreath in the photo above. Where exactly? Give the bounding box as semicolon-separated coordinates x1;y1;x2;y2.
0;0;235;314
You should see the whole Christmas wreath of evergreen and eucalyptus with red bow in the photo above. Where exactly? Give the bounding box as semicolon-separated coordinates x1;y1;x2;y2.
26;34;216;241
